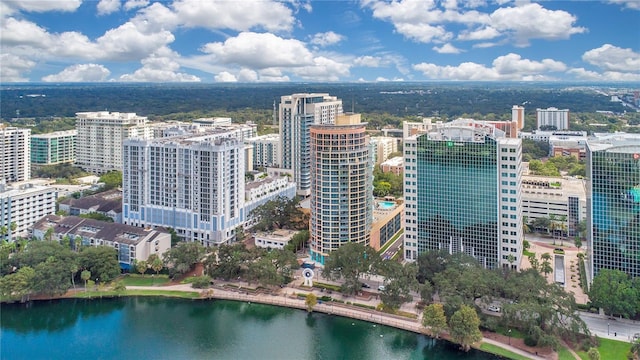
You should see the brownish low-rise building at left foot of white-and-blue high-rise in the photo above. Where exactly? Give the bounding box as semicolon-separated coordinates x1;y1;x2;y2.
58;189;122;223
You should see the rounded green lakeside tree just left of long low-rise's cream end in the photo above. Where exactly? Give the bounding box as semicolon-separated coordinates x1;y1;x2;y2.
78;246;120;283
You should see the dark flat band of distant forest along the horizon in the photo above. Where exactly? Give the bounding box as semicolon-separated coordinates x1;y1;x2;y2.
0;83;625;121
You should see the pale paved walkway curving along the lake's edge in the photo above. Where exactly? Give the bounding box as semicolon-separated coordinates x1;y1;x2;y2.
127;283;544;360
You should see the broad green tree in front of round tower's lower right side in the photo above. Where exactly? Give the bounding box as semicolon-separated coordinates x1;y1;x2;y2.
322;242;380;295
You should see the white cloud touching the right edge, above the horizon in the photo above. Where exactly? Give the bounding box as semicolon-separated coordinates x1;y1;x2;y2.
582;44;640;72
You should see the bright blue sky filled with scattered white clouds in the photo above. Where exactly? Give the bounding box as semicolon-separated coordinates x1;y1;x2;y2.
0;0;640;83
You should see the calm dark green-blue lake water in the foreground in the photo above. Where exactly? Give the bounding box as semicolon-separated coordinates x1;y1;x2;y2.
0;297;497;360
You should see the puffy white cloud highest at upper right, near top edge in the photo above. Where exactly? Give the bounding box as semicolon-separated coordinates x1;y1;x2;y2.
491;3;587;46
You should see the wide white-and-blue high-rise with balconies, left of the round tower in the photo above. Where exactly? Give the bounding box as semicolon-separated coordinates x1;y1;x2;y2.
122;129;245;246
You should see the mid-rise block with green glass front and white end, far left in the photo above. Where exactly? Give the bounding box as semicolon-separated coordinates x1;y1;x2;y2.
31;130;78;165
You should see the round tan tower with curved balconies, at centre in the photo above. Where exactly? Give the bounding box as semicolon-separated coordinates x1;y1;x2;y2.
309;114;373;264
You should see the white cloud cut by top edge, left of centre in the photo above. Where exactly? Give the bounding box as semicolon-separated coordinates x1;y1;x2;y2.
172;0;295;32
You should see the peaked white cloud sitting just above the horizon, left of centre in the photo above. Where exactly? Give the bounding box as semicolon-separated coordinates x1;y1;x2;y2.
120;52;200;82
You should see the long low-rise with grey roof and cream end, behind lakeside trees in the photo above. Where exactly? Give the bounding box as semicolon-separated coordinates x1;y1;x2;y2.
32;215;171;269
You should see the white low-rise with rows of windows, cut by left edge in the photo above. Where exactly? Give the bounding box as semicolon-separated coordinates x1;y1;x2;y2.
0;182;58;240
